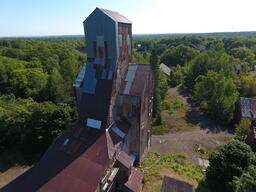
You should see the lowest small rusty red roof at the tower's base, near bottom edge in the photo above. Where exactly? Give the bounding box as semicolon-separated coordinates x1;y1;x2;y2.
124;167;143;192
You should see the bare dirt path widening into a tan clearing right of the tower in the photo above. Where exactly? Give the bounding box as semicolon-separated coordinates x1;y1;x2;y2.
151;88;233;163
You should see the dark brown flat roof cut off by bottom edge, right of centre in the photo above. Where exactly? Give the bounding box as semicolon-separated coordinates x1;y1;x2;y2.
161;176;193;192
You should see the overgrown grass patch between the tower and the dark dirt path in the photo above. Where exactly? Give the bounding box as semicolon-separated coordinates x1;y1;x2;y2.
152;90;193;135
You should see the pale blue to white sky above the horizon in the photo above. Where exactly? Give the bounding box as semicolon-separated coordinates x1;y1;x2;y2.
0;0;256;37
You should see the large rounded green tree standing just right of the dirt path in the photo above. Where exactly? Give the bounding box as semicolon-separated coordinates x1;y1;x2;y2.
194;71;238;124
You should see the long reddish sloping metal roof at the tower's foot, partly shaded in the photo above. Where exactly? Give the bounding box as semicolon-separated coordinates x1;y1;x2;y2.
2;123;115;192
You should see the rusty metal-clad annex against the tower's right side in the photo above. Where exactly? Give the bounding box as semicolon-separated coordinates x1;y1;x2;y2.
119;64;153;161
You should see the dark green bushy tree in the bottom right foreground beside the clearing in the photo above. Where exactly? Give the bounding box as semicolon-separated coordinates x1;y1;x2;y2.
206;141;253;192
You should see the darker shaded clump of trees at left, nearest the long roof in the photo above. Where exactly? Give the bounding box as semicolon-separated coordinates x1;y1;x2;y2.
0;95;74;152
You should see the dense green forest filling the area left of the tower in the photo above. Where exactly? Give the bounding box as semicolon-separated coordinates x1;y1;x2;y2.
0;39;86;153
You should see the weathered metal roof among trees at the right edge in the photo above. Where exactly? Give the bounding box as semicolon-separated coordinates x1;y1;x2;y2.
240;97;256;118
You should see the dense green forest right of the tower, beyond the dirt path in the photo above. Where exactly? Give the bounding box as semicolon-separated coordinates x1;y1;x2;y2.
134;36;256;125
